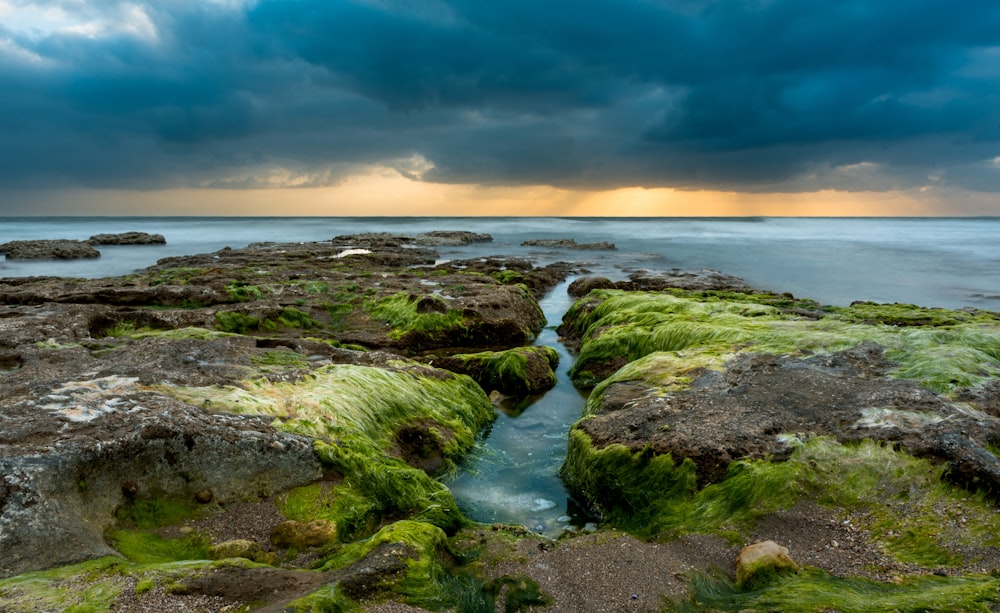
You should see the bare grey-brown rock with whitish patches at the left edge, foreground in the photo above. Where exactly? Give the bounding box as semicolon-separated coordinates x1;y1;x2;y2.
0;377;323;577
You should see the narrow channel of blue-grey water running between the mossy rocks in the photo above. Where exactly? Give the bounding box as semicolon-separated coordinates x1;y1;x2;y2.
447;279;587;537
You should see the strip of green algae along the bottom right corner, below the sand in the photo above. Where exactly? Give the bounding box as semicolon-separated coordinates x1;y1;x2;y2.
665;570;1000;613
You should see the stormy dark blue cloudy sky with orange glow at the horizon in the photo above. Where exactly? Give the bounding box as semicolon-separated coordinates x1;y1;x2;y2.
0;0;1000;216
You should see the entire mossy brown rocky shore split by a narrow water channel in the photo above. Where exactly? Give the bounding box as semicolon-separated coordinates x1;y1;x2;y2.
0;232;1000;612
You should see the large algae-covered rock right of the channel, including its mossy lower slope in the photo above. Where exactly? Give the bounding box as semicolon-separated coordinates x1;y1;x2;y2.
560;289;1000;596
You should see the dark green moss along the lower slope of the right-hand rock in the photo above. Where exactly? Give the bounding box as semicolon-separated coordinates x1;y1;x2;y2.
562;430;1000;566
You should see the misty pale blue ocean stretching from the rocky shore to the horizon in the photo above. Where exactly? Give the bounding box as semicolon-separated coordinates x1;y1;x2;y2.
0;217;1000;311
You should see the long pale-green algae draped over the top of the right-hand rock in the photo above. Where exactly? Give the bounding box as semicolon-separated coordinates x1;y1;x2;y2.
564;290;1000;393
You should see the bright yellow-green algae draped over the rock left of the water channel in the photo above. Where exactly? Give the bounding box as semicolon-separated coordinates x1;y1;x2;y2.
163;361;495;539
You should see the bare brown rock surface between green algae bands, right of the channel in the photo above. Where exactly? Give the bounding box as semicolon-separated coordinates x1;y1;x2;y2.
579;343;1000;492
